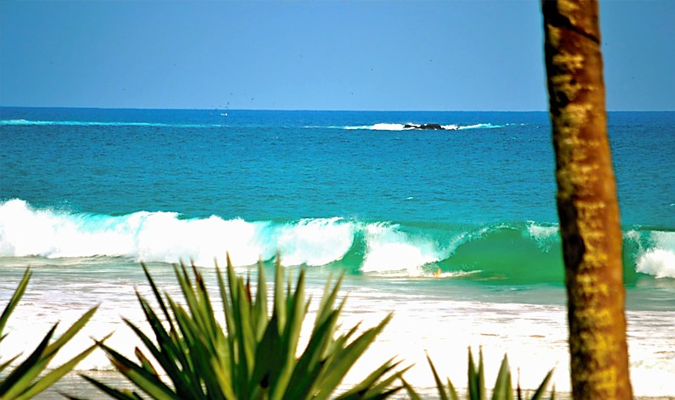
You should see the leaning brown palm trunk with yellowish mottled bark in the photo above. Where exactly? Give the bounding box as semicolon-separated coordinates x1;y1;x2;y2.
542;0;632;400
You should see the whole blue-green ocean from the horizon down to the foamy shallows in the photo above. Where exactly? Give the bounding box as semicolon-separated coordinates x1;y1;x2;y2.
0;107;675;398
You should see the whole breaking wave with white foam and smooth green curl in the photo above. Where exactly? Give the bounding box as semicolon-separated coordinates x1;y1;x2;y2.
0;199;675;283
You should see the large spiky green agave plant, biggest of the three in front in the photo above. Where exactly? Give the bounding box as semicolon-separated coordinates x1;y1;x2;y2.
83;258;402;400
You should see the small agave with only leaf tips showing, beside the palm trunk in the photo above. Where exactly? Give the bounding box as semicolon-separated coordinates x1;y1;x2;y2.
401;349;555;400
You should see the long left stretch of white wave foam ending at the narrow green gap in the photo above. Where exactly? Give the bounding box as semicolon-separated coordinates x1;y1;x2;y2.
0;199;354;266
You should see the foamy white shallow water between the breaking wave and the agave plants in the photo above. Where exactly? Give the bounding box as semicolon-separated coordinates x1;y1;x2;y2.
0;259;675;396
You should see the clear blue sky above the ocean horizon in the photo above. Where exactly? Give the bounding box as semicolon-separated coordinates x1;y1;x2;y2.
0;0;675;111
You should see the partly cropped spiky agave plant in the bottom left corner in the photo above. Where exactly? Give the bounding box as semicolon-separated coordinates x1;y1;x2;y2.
0;268;96;400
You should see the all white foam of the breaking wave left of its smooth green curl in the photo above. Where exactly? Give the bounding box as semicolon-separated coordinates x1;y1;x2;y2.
0;199;482;276
